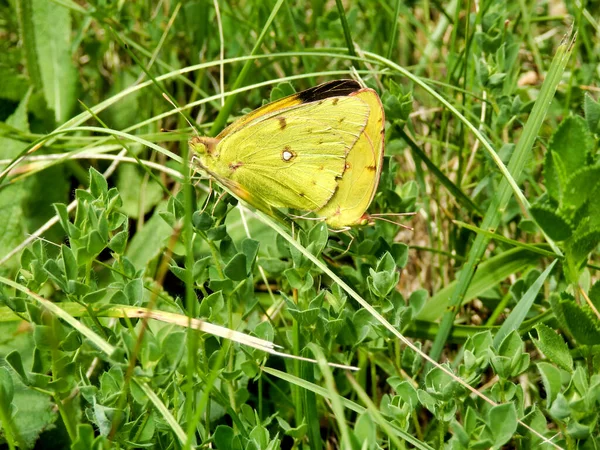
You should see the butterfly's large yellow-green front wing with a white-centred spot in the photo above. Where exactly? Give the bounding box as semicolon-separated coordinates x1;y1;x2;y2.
203;93;370;211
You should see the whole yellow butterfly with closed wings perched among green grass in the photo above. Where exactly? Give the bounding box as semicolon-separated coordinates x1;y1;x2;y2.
190;80;385;229
